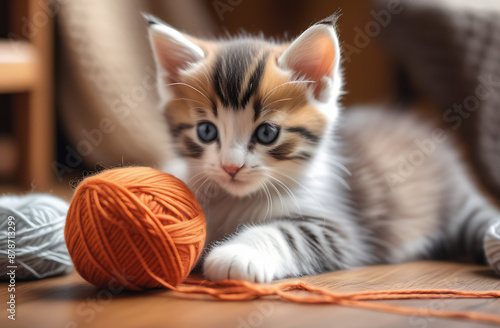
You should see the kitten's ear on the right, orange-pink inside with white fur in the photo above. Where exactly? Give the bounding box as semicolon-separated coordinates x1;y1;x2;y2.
278;15;340;101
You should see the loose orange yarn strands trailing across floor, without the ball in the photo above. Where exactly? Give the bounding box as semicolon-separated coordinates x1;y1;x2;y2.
173;279;500;324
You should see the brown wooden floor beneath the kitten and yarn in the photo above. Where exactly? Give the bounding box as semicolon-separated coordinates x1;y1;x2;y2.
0;262;500;328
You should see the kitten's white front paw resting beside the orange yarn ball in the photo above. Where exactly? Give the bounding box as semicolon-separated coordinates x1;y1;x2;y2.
203;243;276;283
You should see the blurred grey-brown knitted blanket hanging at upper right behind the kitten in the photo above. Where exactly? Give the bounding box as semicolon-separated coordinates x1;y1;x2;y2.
372;0;500;199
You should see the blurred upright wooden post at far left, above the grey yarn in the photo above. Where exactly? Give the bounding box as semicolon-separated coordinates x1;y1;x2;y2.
11;0;55;191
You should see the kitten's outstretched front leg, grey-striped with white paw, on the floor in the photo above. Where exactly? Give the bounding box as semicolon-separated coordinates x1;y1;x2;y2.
203;218;362;283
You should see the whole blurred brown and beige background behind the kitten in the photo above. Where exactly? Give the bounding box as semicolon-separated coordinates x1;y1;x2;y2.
0;0;500;199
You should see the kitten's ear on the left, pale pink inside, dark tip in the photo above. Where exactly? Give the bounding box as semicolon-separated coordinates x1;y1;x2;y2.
143;14;205;77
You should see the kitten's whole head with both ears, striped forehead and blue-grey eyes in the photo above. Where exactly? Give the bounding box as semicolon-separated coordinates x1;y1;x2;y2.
150;15;338;196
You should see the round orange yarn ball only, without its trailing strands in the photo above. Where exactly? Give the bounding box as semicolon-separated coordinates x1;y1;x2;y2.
64;167;206;290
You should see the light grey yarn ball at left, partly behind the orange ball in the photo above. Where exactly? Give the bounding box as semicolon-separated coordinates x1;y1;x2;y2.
0;194;73;281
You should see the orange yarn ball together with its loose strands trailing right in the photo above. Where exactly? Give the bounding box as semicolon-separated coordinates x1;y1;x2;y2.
64;167;500;324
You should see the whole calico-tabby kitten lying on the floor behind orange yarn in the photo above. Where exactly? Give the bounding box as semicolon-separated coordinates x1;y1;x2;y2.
146;15;500;282
